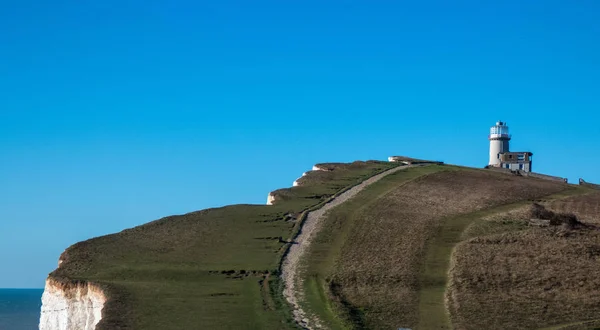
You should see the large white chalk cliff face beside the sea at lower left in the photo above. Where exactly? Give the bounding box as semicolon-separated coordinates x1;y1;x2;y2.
40;278;106;330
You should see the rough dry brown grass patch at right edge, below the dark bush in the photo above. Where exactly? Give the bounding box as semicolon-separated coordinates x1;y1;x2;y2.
447;193;600;329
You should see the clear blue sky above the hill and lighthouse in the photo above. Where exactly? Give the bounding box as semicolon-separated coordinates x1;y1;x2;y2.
0;0;600;287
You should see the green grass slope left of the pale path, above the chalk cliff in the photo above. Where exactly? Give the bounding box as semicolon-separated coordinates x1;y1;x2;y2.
50;161;397;330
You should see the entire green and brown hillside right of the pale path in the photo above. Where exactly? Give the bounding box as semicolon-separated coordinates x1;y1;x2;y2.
303;166;600;329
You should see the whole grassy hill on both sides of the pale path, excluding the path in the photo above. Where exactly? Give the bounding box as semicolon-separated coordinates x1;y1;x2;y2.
51;161;600;329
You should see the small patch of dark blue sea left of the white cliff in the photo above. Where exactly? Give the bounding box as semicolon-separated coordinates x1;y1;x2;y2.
0;289;44;330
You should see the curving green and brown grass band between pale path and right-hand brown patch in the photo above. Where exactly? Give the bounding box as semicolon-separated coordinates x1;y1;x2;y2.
305;166;567;329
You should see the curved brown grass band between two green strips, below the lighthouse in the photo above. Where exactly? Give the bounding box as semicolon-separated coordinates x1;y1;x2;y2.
310;169;565;329
